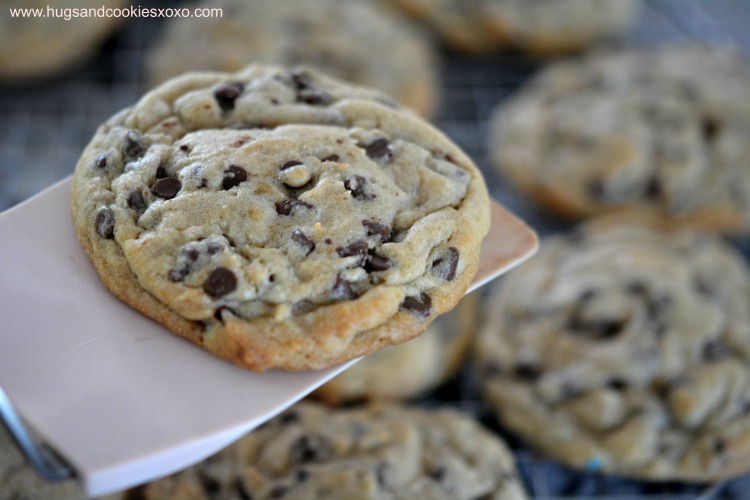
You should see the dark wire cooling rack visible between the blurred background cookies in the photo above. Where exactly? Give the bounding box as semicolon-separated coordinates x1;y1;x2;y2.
0;0;750;500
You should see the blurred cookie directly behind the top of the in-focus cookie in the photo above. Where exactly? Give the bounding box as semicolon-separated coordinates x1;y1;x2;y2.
146;0;440;116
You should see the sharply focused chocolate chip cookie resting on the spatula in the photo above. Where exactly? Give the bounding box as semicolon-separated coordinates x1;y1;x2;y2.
71;66;489;371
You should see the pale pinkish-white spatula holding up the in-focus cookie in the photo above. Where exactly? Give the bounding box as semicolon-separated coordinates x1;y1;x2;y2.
0;179;538;496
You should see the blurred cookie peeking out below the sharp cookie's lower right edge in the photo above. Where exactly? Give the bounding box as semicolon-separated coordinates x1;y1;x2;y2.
313;293;478;405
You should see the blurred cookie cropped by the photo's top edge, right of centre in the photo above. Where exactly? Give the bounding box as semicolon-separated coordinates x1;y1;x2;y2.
384;0;640;55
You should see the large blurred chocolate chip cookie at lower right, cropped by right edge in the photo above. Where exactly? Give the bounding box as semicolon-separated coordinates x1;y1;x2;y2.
476;216;750;482
